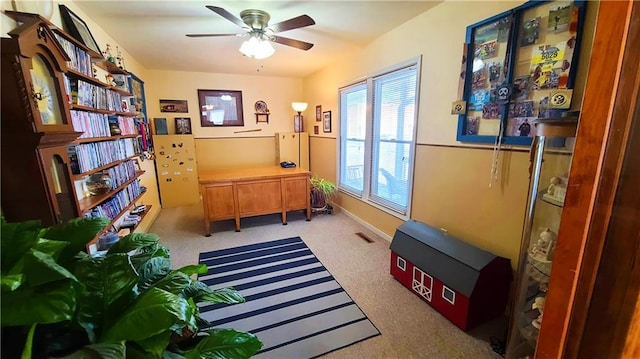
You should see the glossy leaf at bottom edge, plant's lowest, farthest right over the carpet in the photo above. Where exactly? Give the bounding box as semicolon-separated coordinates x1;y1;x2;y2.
185;329;263;359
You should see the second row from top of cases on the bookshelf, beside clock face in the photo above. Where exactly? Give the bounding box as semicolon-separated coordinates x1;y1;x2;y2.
65;76;128;112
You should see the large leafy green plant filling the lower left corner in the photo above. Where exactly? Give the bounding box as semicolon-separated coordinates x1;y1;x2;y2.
0;218;262;359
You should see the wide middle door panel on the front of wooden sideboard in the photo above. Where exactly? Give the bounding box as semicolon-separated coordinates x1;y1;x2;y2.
237;179;282;216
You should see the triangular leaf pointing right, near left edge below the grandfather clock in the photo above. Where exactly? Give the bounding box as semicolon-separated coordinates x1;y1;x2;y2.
24;249;77;287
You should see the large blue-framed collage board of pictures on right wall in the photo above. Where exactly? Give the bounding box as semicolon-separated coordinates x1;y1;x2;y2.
452;1;587;145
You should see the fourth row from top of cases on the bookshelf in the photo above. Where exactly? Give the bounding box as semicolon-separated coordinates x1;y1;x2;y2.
67;138;140;174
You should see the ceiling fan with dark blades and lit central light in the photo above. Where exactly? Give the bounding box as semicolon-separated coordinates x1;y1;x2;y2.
187;5;316;50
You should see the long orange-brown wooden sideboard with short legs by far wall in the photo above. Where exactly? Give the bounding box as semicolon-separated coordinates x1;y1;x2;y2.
198;166;311;237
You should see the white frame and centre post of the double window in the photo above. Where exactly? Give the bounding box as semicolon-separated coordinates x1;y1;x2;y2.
336;55;422;220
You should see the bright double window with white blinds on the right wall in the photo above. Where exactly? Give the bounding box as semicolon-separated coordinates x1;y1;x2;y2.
339;59;420;217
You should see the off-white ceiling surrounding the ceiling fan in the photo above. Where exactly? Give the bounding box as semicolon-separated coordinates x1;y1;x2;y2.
74;0;439;77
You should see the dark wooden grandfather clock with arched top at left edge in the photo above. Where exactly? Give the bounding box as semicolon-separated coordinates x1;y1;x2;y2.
1;12;81;225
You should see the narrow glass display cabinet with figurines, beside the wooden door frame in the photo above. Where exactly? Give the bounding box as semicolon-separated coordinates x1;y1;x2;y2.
507;112;578;359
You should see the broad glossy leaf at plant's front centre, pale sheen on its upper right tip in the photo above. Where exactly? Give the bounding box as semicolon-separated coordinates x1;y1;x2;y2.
101;288;195;342
